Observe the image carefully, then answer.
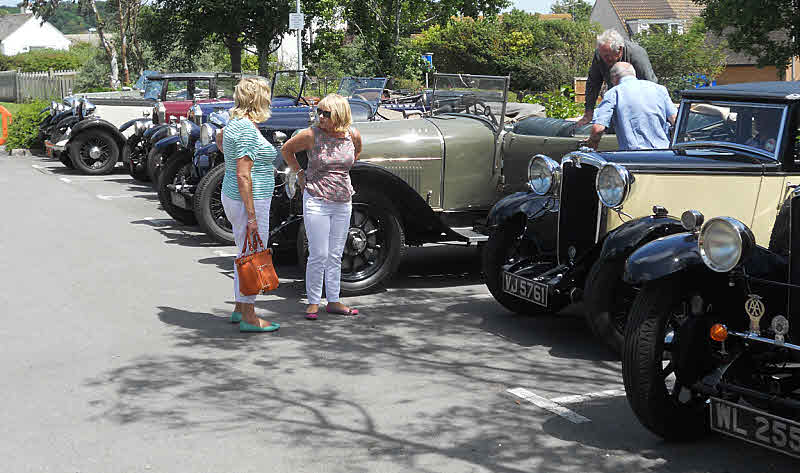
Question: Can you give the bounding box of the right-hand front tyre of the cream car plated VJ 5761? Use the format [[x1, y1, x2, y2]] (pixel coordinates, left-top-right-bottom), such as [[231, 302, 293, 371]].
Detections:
[[584, 259, 636, 355]]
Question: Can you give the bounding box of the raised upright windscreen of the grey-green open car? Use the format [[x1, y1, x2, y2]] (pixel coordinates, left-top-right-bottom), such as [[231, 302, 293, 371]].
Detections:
[[431, 74, 508, 125]]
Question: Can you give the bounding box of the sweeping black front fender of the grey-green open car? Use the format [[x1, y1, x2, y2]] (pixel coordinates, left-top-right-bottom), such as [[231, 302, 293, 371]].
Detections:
[[350, 162, 448, 243]]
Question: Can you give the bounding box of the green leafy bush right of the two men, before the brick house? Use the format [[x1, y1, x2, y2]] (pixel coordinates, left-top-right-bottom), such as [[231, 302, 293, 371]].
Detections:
[[635, 19, 725, 99]]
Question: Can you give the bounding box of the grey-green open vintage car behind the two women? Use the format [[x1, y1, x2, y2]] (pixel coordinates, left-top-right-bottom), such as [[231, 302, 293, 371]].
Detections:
[[184, 74, 617, 294]]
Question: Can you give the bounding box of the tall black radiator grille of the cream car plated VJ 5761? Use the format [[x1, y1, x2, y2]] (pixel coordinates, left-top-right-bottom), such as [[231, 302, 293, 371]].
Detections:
[[558, 162, 599, 263]]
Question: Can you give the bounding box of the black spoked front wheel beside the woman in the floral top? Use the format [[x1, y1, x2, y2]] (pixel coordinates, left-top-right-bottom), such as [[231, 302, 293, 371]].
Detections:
[[297, 191, 405, 296]]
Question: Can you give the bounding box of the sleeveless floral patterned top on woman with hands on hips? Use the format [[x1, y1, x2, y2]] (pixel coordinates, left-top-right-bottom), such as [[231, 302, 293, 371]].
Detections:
[[306, 126, 356, 202]]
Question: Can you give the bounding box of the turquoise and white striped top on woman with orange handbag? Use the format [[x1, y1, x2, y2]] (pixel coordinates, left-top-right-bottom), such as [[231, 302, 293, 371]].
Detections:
[[222, 118, 277, 200]]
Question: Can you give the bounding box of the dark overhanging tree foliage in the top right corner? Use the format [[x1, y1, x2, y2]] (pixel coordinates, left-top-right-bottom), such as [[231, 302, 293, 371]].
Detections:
[[694, 0, 800, 69]]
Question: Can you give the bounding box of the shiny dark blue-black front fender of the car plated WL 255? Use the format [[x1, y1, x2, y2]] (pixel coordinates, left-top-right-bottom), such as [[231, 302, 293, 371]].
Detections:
[[623, 231, 710, 284]]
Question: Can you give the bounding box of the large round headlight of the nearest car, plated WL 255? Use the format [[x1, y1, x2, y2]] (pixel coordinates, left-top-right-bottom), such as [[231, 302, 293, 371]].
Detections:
[[697, 217, 755, 273]]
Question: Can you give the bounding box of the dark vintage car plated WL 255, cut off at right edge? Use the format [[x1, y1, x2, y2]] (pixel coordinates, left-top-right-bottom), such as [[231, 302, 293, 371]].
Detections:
[[622, 206, 800, 458]]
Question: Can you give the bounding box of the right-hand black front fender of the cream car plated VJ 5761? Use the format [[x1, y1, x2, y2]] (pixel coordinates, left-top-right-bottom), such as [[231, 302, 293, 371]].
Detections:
[[598, 215, 686, 260]]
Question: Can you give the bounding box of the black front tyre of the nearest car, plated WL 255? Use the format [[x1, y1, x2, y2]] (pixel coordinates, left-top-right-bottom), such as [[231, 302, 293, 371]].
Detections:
[[622, 277, 708, 441]]
